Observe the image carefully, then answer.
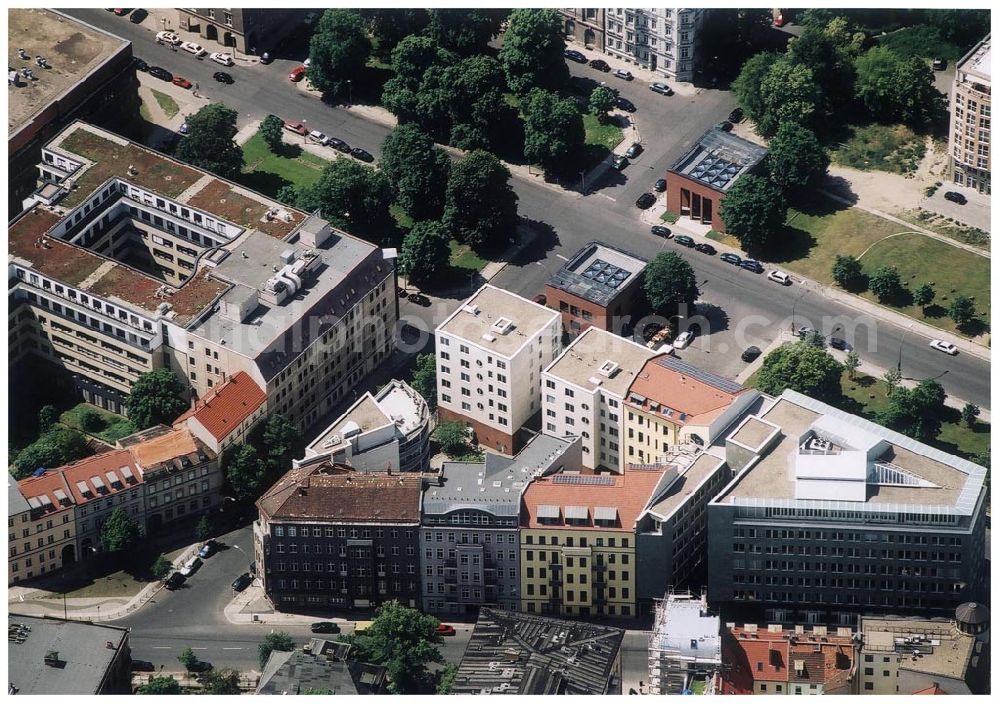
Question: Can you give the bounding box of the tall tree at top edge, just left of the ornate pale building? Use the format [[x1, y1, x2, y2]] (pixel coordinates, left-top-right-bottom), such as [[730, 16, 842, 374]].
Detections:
[[500, 8, 569, 95]]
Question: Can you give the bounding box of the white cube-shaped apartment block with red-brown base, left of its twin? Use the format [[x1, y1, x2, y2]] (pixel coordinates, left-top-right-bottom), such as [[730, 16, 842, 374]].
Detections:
[[435, 284, 562, 455]]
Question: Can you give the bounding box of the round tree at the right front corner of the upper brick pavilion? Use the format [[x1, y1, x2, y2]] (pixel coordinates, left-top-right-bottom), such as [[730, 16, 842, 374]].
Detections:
[[720, 174, 787, 253]]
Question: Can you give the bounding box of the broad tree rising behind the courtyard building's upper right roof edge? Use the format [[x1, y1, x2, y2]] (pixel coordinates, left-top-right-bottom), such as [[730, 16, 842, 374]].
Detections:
[[299, 159, 392, 244]]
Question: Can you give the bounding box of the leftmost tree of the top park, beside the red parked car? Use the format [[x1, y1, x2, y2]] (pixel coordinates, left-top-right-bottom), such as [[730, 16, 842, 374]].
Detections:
[[306, 9, 372, 95]]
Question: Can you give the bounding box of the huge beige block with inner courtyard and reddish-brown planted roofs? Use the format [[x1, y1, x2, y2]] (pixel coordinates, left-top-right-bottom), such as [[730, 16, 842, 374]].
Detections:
[[8, 122, 397, 427]]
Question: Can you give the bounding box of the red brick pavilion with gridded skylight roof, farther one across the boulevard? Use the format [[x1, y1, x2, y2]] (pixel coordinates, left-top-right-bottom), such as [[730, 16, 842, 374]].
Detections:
[[666, 127, 767, 232]]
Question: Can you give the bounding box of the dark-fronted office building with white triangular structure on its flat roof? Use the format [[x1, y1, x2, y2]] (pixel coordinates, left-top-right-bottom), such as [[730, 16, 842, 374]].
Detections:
[[708, 390, 987, 625]]
